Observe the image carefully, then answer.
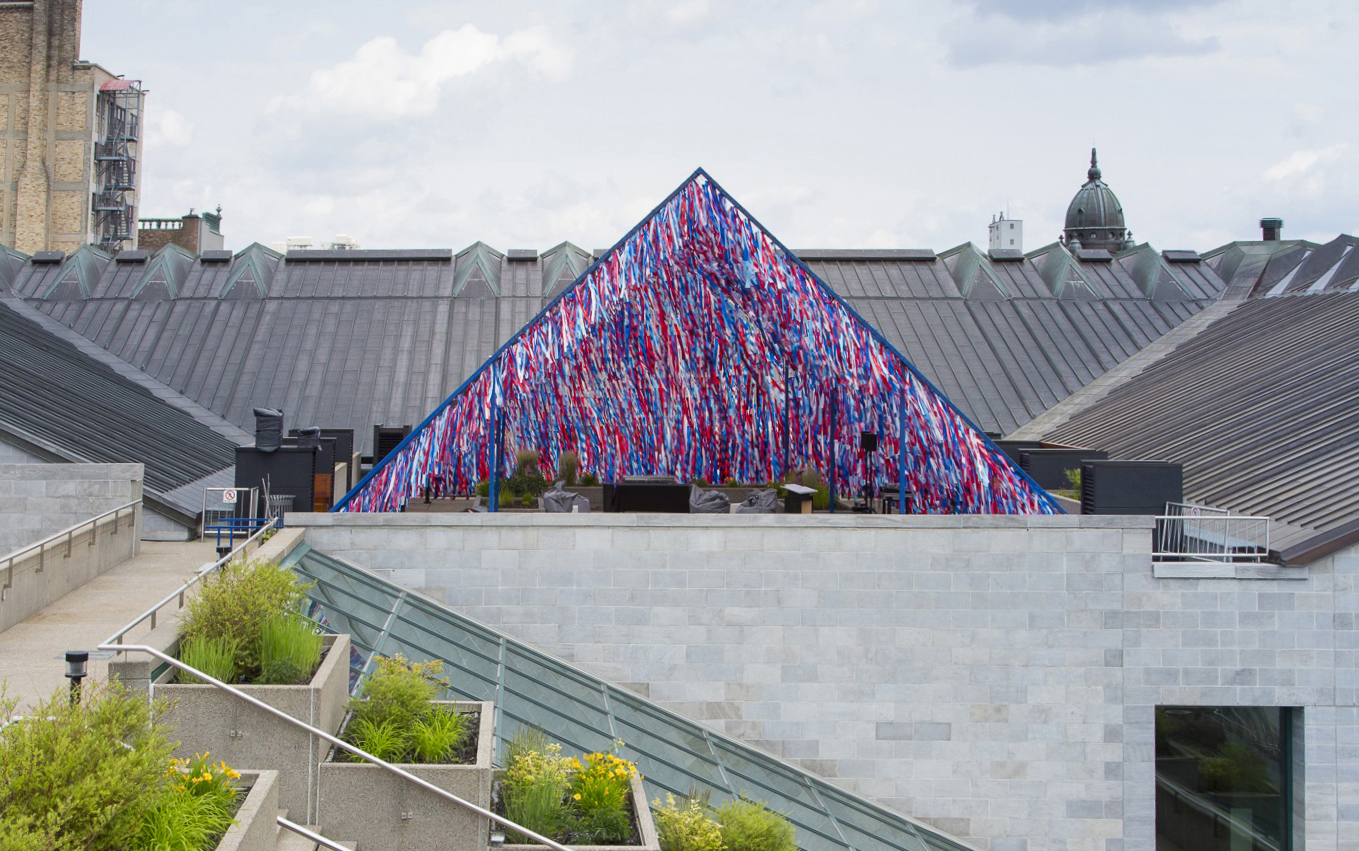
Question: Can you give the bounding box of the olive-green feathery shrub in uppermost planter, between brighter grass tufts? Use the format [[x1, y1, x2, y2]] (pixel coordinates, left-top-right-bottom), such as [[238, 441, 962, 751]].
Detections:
[[182, 560, 307, 680]]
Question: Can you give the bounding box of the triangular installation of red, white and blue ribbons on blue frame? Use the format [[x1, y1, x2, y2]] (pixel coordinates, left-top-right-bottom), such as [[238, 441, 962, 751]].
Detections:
[[334, 169, 1061, 514]]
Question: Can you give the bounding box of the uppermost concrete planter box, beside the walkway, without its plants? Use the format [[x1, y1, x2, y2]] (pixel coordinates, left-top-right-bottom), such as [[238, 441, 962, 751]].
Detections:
[[155, 635, 349, 824]]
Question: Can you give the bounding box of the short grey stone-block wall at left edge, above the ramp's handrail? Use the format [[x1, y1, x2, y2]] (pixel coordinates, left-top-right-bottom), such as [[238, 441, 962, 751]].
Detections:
[[0, 459, 144, 553]]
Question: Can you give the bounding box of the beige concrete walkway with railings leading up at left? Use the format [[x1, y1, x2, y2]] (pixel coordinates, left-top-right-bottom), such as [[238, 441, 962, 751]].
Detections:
[[0, 541, 217, 712]]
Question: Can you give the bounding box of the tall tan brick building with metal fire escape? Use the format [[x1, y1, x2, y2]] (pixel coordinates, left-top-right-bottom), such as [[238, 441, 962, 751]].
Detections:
[[0, 0, 145, 254]]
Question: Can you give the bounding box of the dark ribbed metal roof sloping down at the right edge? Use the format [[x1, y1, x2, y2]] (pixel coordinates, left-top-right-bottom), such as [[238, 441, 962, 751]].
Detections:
[[1046, 285, 1359, 549]]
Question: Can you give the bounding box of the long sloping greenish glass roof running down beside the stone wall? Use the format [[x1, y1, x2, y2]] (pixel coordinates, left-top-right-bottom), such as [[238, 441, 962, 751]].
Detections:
[[287, 545, 969, 851]]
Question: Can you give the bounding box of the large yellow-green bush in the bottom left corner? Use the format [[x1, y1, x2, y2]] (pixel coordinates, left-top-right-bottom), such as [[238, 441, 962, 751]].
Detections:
[[0, 685, 171, 851]]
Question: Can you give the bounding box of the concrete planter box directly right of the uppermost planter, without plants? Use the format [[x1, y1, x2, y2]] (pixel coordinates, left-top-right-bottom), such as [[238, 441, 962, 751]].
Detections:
[[317, 701, 495, 851]]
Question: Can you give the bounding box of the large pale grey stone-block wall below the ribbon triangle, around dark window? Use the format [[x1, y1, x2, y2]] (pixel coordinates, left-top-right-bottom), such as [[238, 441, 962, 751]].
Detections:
[[297, 514, 1359, 851]]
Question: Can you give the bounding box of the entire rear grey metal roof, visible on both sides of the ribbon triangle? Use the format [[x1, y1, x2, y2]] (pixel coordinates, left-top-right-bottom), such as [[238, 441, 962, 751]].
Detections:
[[5, 235, 1223, 453]]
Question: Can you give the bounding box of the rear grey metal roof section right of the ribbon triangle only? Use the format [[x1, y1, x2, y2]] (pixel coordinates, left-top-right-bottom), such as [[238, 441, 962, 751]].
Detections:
[[803, 243, 1223, 434]]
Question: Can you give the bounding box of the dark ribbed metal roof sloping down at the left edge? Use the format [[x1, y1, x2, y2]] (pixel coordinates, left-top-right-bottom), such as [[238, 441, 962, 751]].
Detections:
[[0, 297, 235, 505]]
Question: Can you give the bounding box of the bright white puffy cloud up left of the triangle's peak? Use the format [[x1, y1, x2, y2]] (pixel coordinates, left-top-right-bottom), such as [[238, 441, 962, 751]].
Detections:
[[306, 23, 572, 118]]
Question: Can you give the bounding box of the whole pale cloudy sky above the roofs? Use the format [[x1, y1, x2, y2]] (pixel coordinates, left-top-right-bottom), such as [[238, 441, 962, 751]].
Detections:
[[82, 0, 1359, 250]]
